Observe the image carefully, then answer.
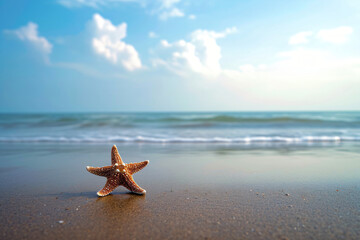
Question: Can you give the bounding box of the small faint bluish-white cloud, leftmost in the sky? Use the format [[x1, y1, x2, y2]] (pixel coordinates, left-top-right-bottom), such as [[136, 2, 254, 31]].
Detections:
[[5, 22, 53, 54]]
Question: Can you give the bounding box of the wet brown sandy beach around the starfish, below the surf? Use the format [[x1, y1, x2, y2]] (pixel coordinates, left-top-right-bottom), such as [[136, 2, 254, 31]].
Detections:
[[0, 143, 360, 239]]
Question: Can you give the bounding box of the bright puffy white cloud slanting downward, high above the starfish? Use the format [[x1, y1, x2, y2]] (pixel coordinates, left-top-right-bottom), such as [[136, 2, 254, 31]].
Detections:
[[92, 14, 141, 71]]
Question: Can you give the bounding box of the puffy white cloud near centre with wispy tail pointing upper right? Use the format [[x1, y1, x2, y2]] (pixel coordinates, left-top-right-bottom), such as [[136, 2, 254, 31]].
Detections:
[[155, 27, 237, 77]]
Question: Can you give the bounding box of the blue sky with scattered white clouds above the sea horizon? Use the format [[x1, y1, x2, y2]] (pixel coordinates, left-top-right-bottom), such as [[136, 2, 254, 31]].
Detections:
[[0, 0, 360, 112]]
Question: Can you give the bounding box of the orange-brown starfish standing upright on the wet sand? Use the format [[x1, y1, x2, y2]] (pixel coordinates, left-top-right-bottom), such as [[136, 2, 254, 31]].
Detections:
[[86, 145, 149, 197]]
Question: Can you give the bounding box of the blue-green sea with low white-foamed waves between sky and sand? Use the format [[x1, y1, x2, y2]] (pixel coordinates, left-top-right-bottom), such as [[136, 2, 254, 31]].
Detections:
[[0, 112, 360, 145]]
